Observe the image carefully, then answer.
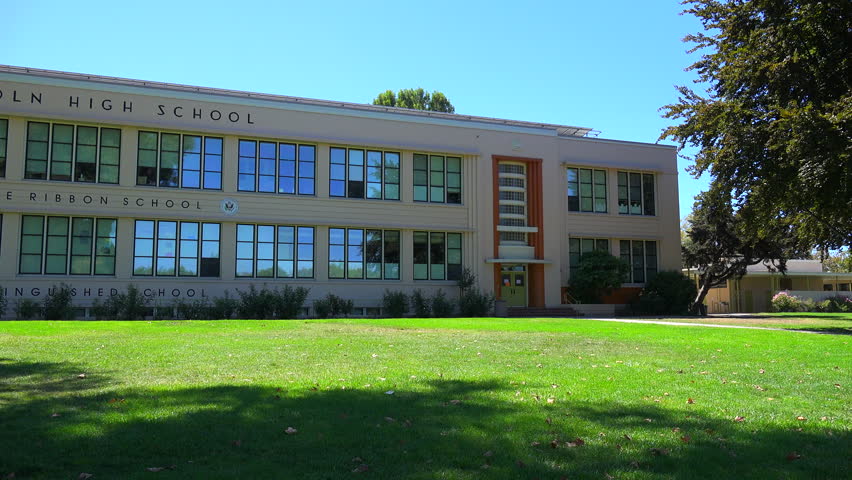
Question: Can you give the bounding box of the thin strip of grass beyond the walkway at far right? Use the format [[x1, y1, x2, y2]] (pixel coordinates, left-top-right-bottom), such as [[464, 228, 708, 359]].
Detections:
[[624, 312, 852, 335]]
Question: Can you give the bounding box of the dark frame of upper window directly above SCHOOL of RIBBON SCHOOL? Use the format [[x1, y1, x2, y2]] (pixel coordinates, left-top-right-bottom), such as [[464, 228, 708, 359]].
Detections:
[[135, 129, 225, 191]]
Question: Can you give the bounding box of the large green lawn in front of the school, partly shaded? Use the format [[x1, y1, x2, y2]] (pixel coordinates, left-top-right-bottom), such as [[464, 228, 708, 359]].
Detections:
[[0, 319, 852, 480]]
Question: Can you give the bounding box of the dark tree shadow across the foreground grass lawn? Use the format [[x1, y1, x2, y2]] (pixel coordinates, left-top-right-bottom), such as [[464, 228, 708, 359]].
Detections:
[[0, 360, 850, 480]]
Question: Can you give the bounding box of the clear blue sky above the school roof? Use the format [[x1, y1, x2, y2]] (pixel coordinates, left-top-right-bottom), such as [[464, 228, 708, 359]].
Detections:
[[0, 0, 707, 217]]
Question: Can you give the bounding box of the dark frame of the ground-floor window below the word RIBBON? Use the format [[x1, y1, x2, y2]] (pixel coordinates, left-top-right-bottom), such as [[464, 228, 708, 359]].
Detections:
[[18, 215, 118, 277]]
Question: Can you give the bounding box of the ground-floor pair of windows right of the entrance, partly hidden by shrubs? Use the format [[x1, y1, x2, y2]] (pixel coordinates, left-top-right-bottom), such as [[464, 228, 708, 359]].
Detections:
[[568, 237, 658, 283]]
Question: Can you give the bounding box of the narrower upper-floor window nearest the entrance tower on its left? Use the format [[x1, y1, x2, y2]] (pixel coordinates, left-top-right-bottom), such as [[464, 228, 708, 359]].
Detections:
[[414, 153, 461, 203]]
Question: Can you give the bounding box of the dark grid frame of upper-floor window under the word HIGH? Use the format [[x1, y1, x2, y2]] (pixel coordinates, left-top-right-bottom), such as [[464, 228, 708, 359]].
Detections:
[[24, 119, 123, 185]]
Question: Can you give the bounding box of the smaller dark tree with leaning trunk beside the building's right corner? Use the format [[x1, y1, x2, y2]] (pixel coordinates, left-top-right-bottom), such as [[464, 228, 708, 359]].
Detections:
[[682, 188, 808, 313]]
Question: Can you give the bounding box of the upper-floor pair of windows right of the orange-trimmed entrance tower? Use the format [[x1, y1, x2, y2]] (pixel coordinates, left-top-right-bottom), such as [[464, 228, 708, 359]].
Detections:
[[567, 167, 656, 216]]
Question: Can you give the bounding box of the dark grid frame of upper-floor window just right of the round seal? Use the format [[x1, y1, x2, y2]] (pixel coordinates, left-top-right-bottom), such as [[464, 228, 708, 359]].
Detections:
[[237, 138, 317, 196]]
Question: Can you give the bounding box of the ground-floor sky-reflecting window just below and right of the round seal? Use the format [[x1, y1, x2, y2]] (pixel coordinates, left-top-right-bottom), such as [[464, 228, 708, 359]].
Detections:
[[236, 224, 314, 278]]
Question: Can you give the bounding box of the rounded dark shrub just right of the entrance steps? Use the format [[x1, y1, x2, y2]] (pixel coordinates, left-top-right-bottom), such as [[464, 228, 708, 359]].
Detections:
[[571, 252, 630, 303]]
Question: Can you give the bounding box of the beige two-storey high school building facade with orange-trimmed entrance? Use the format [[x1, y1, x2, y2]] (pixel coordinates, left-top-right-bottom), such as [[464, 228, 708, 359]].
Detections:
[[0, 66, 681, 316]]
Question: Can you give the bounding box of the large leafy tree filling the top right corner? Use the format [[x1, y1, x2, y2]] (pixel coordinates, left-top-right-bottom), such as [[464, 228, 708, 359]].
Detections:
[[661, 0, 852, 249]]
